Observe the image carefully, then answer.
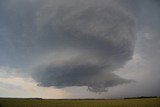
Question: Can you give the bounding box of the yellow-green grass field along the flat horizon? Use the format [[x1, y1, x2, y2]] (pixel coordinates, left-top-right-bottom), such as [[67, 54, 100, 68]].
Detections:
[[0, 98, 160, 107]]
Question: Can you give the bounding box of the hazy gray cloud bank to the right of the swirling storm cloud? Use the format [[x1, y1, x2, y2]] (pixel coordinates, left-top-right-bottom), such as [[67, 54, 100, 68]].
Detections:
[[116, 0, 160, 96]]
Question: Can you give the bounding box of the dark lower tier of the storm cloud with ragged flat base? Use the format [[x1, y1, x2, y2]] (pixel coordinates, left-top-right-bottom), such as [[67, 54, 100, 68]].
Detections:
[[33, 52, 131, 92]]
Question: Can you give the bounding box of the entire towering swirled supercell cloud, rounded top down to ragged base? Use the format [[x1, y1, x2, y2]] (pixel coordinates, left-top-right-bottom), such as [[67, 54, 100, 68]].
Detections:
[[32, 0, 135, 92]]
